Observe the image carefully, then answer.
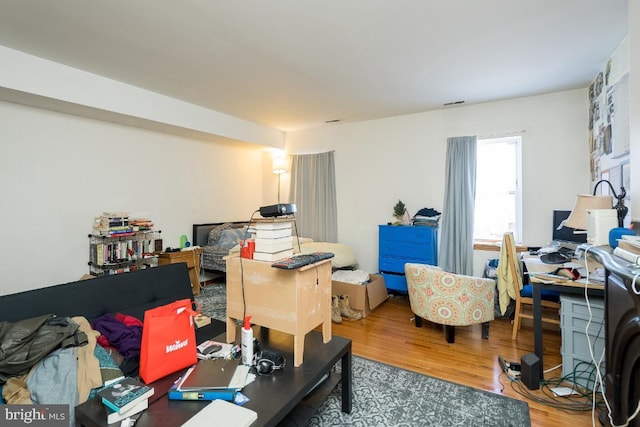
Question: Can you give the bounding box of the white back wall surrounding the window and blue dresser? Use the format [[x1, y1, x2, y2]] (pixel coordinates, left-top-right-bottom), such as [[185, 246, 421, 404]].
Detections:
[[286, 89, 590, 274]]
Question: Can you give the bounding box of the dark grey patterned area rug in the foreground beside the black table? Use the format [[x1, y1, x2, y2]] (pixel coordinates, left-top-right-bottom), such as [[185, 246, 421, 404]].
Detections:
[[307, 356, 531, 427]]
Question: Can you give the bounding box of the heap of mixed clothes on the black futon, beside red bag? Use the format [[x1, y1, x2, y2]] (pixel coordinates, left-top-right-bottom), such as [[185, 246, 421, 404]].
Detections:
[[0, 314, 142, 425]]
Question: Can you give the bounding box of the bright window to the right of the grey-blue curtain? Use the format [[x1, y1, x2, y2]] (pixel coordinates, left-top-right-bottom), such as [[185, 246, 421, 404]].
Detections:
[[473, 136, 522, 242]]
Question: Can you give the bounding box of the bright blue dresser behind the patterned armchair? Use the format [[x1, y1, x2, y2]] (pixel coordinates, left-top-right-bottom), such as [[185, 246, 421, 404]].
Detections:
[[378, 225, 438, 293]]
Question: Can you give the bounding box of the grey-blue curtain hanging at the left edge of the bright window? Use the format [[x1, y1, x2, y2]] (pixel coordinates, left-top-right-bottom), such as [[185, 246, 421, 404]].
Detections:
[[439, 136, 477, 276]]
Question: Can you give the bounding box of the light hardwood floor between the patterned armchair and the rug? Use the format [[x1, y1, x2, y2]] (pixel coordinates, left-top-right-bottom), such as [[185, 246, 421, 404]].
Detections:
[[332, 295, 600, 427]]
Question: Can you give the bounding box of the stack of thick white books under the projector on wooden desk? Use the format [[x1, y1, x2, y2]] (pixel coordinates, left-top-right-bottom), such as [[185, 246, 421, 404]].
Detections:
[[253, 218, 294, 262]]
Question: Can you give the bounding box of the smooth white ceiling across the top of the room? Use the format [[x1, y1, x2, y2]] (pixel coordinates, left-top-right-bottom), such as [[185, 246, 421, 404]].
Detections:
[[0, 0, 628, 131]]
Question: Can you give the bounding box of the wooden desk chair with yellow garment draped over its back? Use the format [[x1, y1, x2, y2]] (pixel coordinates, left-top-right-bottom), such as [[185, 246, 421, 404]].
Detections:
[[498, 233, 560, 340]]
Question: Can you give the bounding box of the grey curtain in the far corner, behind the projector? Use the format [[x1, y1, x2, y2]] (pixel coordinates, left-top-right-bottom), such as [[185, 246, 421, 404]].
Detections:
[[289, 151, 338, 242]]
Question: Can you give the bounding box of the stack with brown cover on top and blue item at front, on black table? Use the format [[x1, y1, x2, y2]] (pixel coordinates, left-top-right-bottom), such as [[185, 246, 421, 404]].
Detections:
[[168, 359, 249, 401]]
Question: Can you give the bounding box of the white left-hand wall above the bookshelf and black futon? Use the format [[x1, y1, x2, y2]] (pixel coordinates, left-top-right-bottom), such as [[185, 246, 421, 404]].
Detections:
[[0, 101, 264, 294]]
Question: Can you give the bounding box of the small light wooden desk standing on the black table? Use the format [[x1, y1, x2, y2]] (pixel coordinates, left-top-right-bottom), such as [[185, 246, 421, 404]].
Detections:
[[226, 255, 331, 367]]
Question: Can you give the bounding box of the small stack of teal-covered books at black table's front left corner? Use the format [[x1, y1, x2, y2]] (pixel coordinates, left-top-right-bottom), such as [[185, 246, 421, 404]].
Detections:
[[96, 377, 155, 424]]
